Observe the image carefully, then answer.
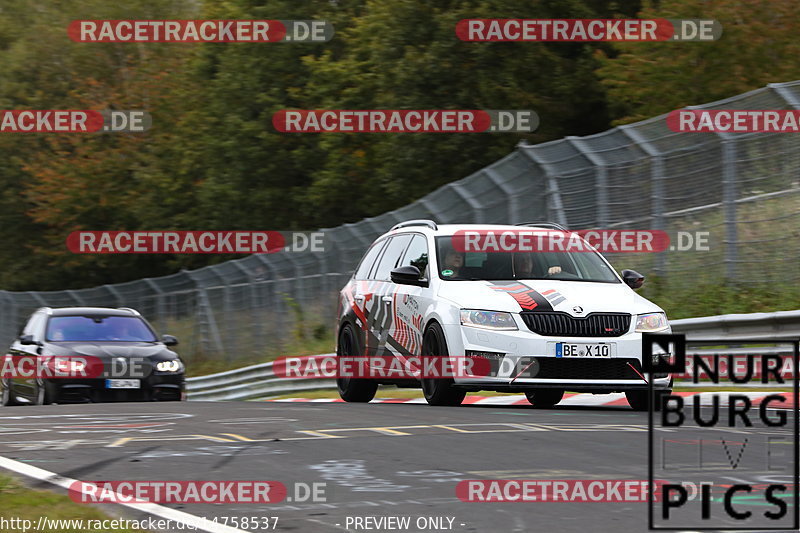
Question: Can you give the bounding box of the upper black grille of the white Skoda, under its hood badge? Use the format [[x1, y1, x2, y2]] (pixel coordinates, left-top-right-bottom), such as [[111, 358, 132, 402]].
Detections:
[[521, 311, 631, 337]]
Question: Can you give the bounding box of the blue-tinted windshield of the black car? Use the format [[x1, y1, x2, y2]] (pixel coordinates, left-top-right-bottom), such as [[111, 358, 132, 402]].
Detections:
[[45, 316, 156, 342]]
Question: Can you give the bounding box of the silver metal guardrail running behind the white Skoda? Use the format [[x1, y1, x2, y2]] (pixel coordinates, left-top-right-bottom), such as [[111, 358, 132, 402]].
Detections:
[[186, 310, 800, 400]]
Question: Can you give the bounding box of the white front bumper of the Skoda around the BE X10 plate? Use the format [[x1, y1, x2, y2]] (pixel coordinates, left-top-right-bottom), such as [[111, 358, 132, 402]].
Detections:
[[444, 324, 671, 392]]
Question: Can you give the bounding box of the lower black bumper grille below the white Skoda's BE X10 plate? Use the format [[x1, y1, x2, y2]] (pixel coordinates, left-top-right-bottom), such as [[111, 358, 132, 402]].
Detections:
[[520, 357, 641, 380]]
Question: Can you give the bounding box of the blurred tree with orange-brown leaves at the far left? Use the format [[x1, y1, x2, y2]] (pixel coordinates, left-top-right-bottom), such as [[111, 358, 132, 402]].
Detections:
[[0, 0, 198, 289]]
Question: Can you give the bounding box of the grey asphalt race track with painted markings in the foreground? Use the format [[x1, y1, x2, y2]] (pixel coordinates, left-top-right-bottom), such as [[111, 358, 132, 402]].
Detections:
[[0, 402, 790, 532]]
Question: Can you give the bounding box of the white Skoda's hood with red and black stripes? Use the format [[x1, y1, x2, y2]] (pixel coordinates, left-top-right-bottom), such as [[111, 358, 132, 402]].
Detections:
[[438, 280, 662, 316]]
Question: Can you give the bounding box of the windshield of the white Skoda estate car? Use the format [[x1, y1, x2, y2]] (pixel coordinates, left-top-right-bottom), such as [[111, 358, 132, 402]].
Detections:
[[436, 236, 620, 283]]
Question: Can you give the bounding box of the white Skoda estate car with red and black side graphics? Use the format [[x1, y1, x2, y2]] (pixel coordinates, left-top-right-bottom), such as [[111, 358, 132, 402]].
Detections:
[[337, 220, 671, 410]]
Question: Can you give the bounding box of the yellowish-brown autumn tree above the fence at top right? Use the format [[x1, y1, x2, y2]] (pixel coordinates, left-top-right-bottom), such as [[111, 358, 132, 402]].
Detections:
[[598, 0, 800, 124]]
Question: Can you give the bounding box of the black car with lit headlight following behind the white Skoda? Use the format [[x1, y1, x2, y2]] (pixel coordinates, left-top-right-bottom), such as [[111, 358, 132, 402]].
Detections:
[[0, 307, 185, 405]]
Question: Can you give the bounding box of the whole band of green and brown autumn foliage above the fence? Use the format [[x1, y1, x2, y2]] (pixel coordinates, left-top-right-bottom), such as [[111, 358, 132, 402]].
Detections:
[[0, 0, 800, 290]]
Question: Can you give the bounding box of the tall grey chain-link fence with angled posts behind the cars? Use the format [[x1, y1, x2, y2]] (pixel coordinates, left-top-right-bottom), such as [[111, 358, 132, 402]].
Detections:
[[0, 81, 800, 361]]
